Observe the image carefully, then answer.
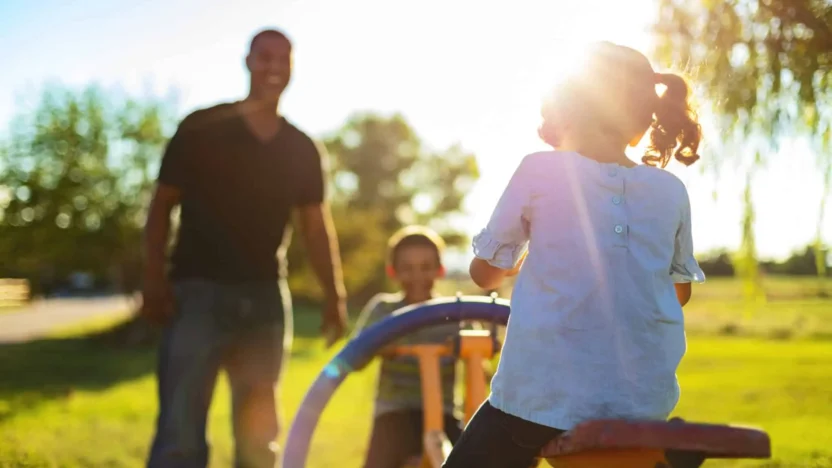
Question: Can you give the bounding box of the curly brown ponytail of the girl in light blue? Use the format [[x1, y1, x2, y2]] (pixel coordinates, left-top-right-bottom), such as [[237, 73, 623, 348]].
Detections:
[[642, 73, 702, 167]]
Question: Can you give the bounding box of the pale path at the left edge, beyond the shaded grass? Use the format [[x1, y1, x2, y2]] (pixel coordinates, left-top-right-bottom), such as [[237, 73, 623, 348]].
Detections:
[[0, 296, 130, 344]]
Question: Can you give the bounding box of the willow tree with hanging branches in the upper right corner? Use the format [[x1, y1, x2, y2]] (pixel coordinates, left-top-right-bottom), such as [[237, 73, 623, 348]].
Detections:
[[655, 0, 832, 292]]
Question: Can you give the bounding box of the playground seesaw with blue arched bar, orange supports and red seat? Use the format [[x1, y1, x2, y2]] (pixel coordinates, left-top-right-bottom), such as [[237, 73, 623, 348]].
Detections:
[[283, 296, 771, 468]]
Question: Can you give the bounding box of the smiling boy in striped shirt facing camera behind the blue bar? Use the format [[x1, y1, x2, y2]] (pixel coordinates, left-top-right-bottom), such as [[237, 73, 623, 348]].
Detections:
[[356, 226, 462, 468]]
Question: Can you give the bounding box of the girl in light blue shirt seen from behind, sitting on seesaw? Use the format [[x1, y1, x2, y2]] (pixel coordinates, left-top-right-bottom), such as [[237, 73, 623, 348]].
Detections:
[[443, 42, 704, 468]]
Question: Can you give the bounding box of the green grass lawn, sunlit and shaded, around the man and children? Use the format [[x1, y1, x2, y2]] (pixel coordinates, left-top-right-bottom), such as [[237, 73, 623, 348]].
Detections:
[[0, 279, 832, 468]]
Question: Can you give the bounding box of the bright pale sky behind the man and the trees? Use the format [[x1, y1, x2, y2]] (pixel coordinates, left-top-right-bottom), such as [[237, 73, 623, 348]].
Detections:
[[0, 0, 832, 266]]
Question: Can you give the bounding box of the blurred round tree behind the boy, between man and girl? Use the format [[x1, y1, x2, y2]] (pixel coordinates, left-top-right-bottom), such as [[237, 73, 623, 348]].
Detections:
[[289, 113, 479, 300]]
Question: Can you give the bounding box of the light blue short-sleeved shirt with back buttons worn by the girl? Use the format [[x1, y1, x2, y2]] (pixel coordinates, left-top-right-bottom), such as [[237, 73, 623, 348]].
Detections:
[[473, 152, 705, 430]]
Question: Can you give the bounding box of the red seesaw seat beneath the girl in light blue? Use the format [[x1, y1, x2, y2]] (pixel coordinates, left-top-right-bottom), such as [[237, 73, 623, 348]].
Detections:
[[541, 419, 771, 468]]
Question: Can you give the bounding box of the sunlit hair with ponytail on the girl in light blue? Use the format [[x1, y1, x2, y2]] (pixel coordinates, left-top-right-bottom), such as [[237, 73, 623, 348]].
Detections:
[[538, 42, 702, 167]]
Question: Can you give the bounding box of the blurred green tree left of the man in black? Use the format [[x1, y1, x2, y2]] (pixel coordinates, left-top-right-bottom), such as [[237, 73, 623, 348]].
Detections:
[[0, 87, 173, 291]]
